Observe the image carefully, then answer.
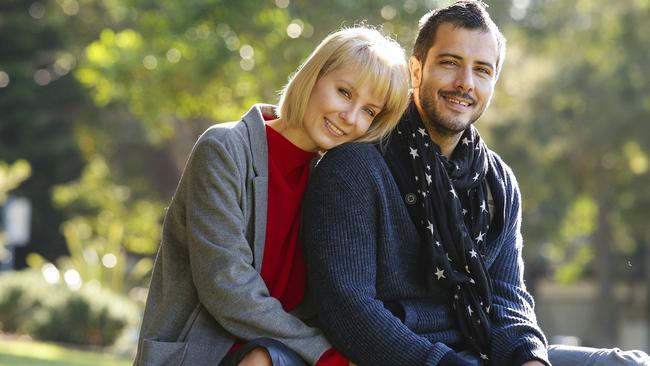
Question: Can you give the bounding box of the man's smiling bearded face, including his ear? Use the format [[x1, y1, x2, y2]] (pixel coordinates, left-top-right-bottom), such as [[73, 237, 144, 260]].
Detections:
[[410, 23, 499, 136]]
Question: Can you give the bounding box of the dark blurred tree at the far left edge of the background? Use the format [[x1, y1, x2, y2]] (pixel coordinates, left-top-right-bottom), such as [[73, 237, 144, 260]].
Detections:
[[0, 0, 85, 267]]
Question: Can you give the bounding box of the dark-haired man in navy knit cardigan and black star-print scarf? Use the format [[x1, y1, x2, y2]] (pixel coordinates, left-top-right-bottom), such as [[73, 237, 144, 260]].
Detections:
[[303, 0, 650, 366]]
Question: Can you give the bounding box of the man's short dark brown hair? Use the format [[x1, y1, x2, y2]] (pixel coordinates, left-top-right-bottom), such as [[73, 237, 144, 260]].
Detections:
[[413, 0, 506, 75]]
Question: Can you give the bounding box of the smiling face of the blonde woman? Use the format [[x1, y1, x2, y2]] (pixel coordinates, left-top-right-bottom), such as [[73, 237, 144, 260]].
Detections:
[[301, 68, 385, 151]]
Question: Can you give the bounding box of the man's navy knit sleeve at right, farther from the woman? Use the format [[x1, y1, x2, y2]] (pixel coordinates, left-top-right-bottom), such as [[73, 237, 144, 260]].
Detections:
[[490, 169, 550, 366]]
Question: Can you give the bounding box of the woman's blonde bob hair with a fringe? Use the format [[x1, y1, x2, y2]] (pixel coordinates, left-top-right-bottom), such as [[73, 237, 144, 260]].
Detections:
[[277, 26, 409, 142]]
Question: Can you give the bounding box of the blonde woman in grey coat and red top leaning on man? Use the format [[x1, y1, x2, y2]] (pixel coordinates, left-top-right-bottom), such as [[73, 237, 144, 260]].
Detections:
[[135, 27, 408, 365]]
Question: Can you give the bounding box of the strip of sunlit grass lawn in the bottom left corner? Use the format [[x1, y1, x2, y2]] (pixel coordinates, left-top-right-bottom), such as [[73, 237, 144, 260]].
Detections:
[[0, 339, 133, 366]]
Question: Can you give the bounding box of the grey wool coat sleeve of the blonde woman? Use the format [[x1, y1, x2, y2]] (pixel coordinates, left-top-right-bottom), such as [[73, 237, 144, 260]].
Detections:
[[183, 133, 330, 365]]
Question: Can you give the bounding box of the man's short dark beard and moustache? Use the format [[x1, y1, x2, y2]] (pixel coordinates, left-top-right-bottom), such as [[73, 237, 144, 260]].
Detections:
[[419, 85, 484, 136]]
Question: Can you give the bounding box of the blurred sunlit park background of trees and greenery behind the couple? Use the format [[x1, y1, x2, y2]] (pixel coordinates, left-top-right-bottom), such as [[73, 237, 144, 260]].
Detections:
[[0, 0, 650, 365]]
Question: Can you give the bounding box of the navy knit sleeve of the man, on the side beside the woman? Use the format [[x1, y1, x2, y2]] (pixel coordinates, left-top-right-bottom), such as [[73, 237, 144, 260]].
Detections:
[[303, 144, 450, 366]]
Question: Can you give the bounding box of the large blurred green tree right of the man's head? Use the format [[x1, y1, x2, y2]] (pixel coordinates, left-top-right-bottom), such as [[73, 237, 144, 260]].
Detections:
[[486, 1, 650, 345]]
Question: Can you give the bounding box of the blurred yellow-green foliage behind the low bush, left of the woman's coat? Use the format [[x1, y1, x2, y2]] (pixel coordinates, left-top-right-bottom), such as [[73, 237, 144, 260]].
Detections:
[[53, 157, 163, 292]]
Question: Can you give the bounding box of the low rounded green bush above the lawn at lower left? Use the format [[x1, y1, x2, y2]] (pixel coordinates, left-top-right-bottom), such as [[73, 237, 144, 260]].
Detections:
[[0, 271, 139, 346]]
